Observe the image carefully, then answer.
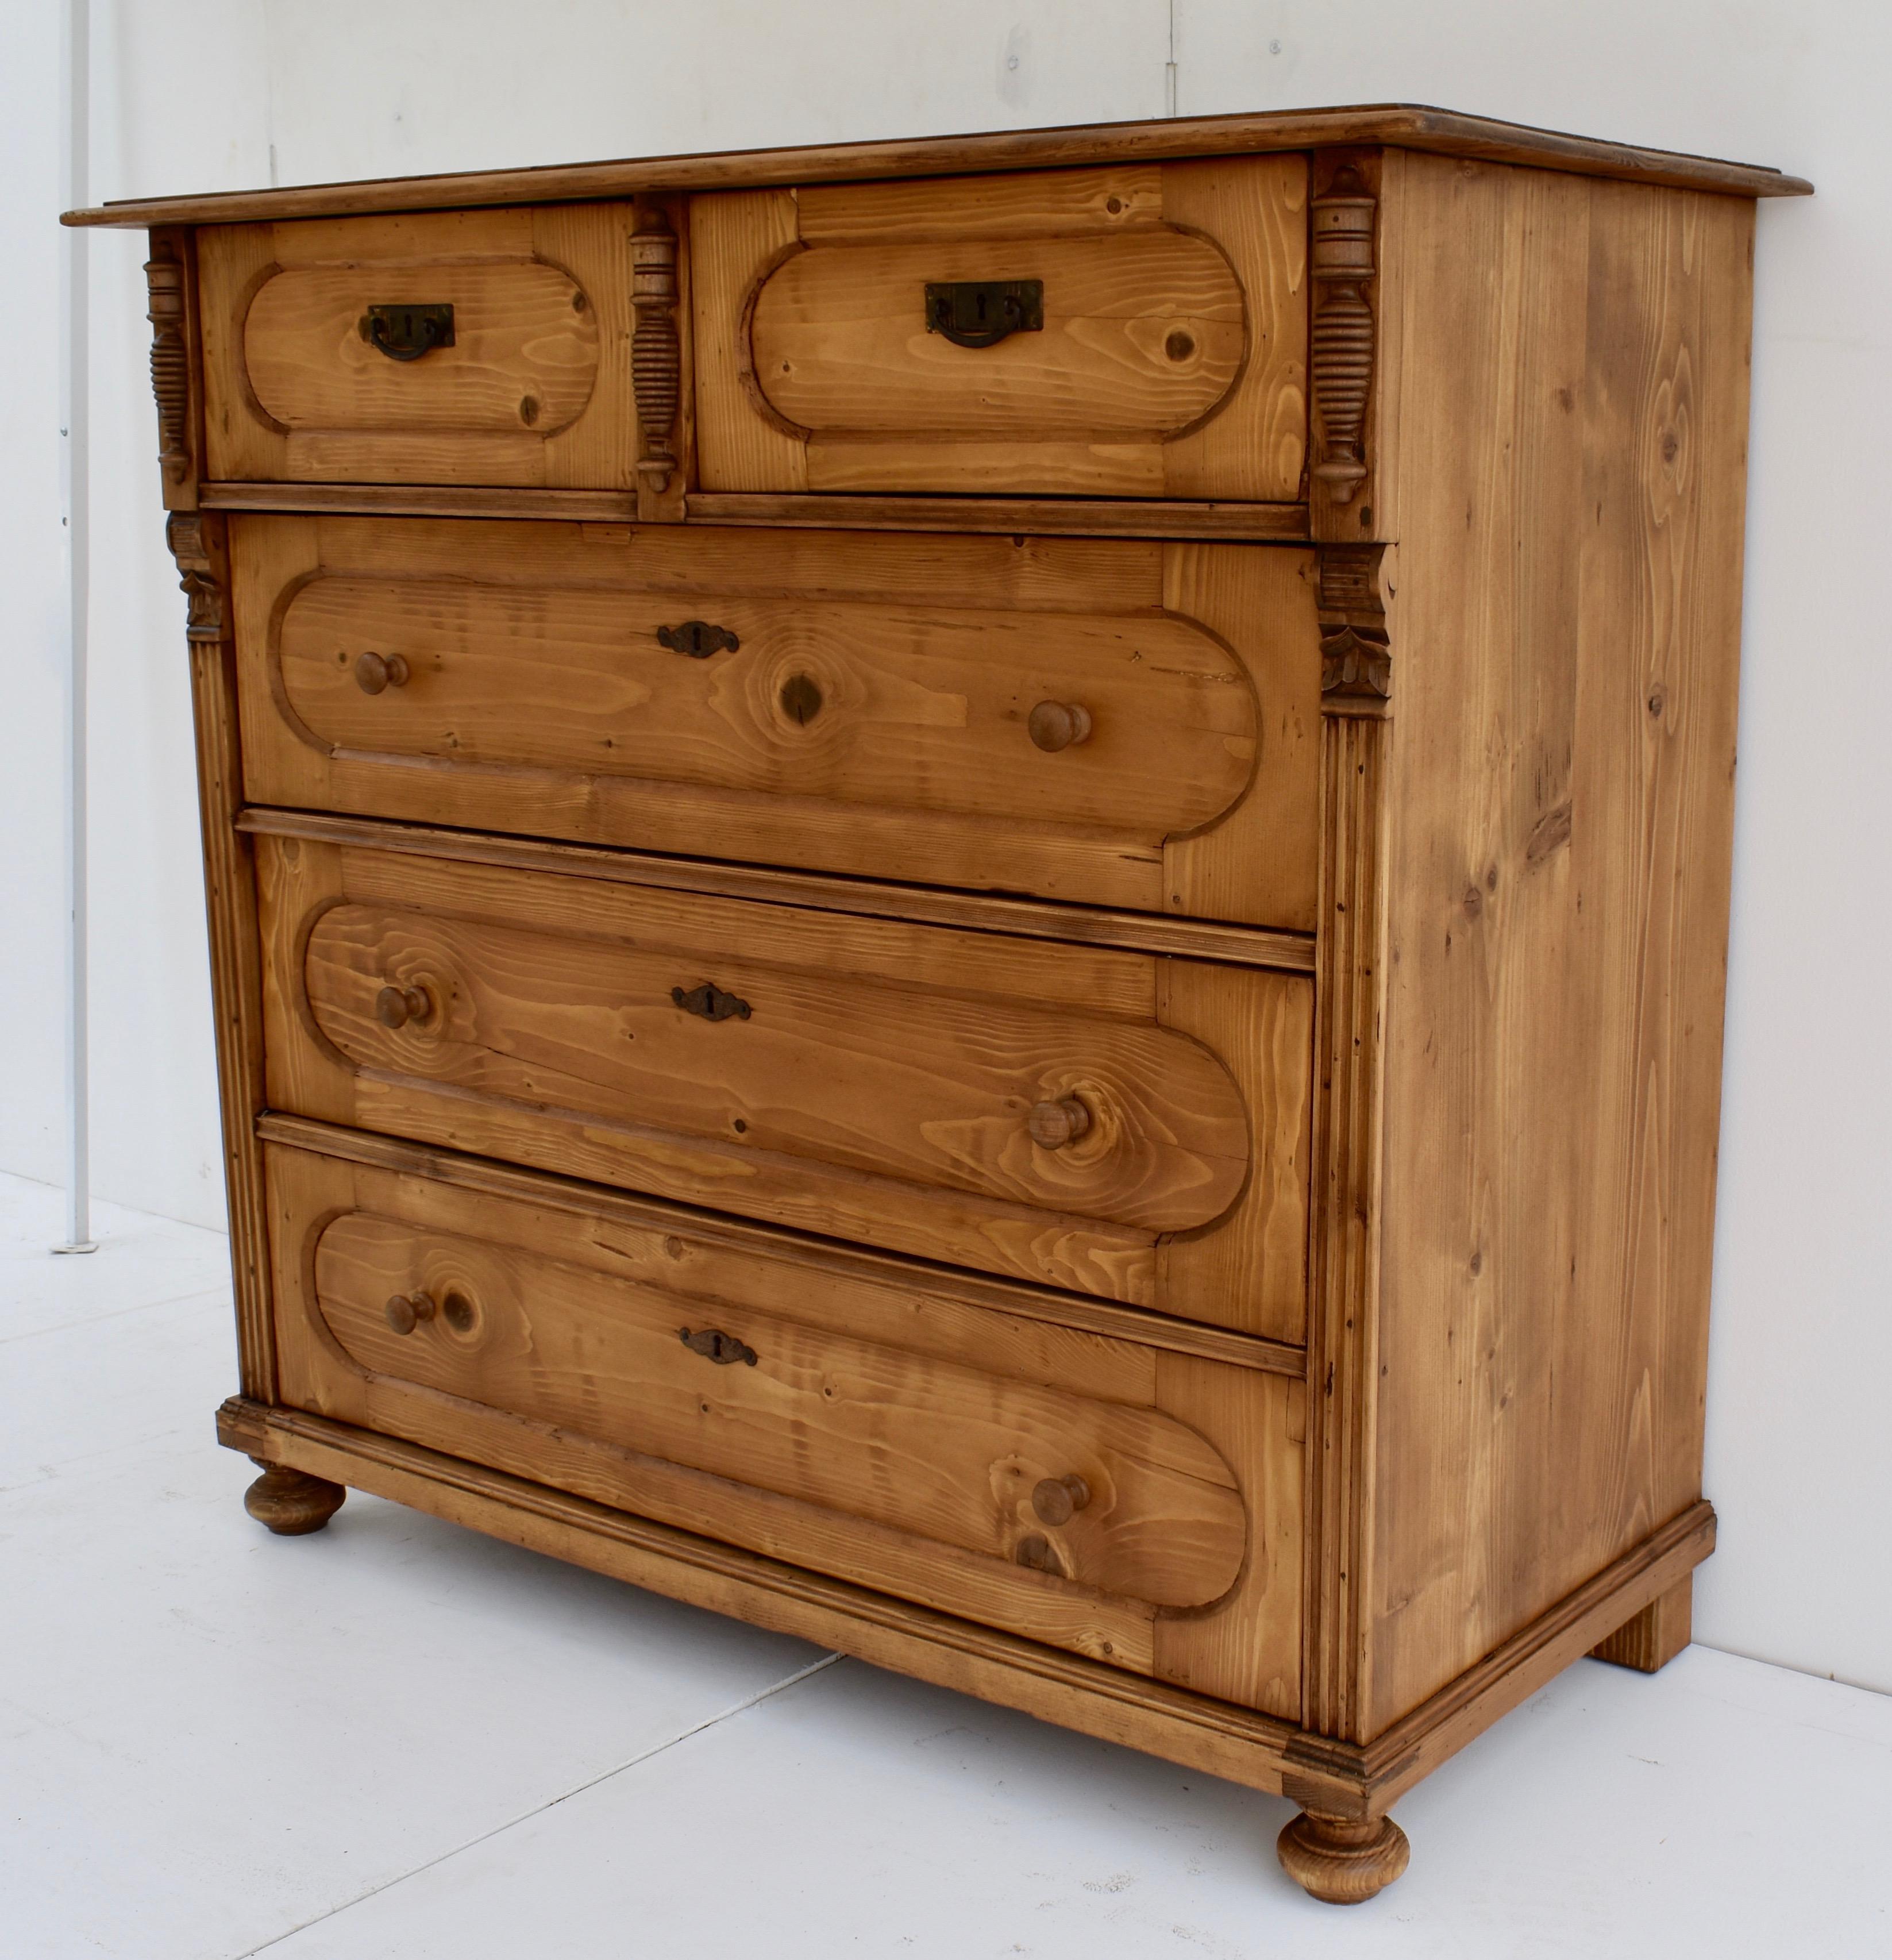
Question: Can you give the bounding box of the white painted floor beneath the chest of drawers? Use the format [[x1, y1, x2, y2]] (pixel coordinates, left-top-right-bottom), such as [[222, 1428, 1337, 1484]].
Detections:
[[0, 1178, 1892, 1960]]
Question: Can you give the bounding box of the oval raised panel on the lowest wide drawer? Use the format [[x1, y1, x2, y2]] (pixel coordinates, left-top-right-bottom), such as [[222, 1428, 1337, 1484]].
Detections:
[[314, 1211, 1247, 1607]]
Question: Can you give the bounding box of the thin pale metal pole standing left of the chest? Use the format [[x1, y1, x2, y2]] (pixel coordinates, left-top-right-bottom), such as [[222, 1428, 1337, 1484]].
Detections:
[[53, 0, 98, 1253]]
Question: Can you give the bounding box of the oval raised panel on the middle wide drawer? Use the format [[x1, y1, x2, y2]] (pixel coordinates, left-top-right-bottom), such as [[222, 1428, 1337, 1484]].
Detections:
[[302, 906, 1249, 1233]]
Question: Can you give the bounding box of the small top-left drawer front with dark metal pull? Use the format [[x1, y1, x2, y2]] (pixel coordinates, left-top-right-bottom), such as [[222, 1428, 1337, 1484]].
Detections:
[[198, 204, 637, 488]]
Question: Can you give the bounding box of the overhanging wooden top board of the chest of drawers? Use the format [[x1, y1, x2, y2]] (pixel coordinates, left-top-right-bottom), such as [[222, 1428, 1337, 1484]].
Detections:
[[61, 104, 1814, 225]]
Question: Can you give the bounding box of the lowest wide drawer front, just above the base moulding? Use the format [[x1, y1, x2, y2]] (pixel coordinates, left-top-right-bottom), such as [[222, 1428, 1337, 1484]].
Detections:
[[267, 1146, 1302, 1715]]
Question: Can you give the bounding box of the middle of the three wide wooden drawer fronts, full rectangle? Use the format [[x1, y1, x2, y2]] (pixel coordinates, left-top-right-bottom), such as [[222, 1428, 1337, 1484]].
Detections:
[[259, 839, 1312, 1339]]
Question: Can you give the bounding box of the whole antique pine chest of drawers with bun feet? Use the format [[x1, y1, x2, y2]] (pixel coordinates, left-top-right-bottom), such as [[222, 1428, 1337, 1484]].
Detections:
[[78, 110, 1806, 1901]]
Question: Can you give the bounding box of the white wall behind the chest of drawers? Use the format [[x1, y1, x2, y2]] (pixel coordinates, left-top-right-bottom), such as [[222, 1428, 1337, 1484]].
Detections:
[[0, 0, 1892, 1689]]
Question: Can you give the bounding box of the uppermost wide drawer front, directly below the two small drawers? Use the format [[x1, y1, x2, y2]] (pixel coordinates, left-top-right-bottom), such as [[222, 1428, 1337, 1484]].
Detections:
[[233, 518, 1320, 931]]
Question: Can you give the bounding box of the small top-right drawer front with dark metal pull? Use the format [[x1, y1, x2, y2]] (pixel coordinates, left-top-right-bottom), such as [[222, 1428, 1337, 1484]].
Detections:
[[690, 157, 1308, 502]]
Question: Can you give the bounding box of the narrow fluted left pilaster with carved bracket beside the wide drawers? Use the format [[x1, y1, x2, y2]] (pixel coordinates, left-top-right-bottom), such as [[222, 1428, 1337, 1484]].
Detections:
[[165, 511, 276, 1401]]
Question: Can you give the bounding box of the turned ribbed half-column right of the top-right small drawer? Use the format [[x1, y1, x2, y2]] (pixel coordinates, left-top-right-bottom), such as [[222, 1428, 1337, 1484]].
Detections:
[[1308, 163, 1378, 506]]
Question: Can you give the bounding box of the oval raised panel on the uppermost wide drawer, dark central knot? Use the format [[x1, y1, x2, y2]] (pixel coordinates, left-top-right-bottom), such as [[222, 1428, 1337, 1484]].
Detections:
[[279, 576, 1255, 845]]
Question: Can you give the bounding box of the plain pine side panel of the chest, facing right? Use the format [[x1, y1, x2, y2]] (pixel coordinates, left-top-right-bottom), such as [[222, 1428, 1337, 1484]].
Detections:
[[1359, 157, 1753, 1735]]
